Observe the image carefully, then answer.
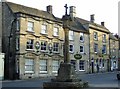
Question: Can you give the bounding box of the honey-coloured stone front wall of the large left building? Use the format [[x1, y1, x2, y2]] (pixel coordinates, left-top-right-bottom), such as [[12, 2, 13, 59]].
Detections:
[[16, 13, 64, 78]]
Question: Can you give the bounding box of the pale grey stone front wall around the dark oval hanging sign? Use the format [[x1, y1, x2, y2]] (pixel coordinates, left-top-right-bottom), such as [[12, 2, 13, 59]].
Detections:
[[70, 32, 89, 73]]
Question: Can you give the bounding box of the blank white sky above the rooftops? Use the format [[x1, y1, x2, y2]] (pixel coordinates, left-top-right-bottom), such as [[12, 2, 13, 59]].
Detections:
[[1, 0, 120, 35]]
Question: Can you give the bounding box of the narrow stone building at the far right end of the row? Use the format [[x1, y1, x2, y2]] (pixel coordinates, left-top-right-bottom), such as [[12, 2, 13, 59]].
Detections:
[[109, 33, 119, 71]]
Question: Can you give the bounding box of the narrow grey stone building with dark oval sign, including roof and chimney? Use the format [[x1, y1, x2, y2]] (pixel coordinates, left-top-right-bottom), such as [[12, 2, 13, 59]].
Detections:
[[69, 6, 89, 73]]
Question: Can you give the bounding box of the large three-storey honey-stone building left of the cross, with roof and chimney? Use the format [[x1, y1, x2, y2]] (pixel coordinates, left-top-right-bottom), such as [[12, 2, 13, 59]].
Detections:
[[3, 2, 64, 79]]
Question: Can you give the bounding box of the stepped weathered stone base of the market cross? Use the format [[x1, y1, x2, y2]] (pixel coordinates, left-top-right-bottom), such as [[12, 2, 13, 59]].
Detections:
[[43, 63, 88, 89]]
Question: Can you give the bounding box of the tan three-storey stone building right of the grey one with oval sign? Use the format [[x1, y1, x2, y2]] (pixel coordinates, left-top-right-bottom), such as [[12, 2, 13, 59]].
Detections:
[[81, 14, 110, 73]]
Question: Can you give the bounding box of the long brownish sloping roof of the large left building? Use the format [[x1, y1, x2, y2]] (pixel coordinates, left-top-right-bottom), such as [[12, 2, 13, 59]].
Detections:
[[6, 2, 61, 22]]
